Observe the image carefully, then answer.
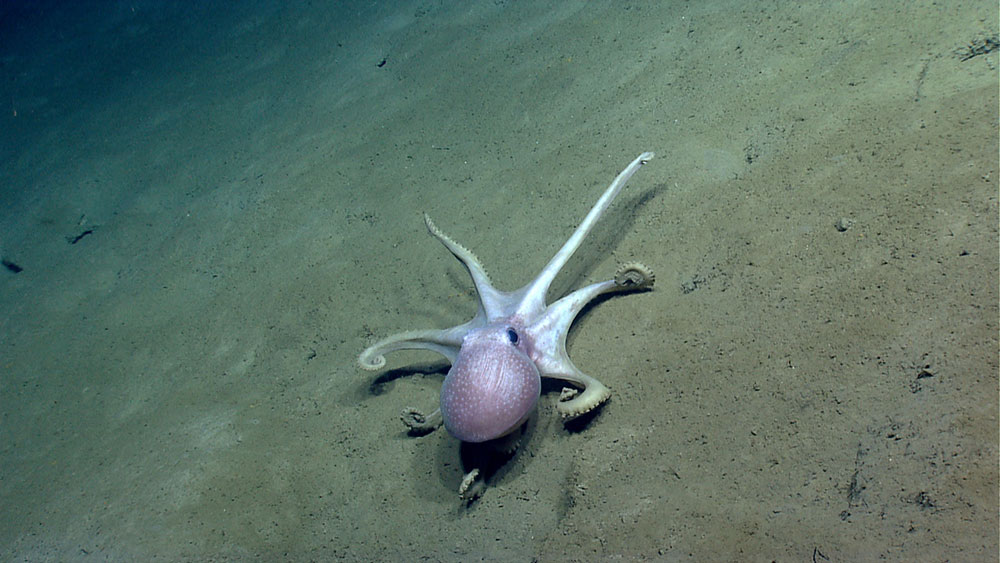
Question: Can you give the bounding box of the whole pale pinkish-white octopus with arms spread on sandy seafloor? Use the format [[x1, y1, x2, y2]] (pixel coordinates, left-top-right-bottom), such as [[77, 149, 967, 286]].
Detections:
[[358, 152, 654, 499]]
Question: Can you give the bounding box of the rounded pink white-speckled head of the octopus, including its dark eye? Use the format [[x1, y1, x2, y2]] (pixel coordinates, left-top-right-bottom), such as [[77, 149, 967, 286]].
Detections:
[[441, 322, 541, 442]]
